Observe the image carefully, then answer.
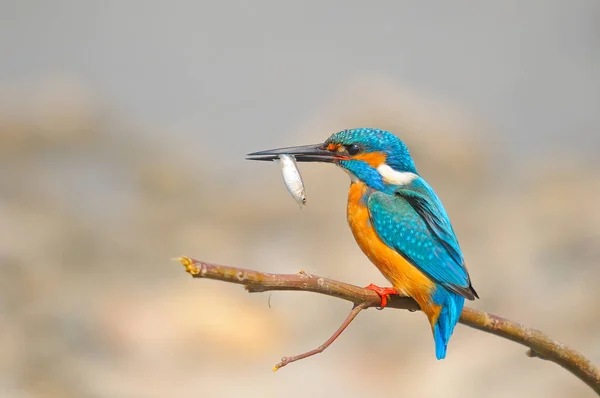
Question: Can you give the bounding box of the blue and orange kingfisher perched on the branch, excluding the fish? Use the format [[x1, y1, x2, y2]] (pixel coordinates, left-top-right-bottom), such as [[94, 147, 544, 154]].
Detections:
[[248, 128, 479, 359]]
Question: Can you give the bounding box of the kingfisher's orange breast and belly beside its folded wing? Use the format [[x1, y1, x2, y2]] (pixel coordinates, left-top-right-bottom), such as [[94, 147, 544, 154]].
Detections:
[[347, 182, 435, 312]]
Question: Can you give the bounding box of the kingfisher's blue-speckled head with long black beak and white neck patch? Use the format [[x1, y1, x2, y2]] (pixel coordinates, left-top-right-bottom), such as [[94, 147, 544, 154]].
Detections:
[[248, 128, 418, 190]]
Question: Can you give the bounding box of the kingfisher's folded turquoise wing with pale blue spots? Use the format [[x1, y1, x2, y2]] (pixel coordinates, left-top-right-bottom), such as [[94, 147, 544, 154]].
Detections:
[[368, 178, 477, 300]]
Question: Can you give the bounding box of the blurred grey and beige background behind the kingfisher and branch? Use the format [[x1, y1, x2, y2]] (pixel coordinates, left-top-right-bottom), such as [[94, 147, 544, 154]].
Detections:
[[0, 0, 600, 398]]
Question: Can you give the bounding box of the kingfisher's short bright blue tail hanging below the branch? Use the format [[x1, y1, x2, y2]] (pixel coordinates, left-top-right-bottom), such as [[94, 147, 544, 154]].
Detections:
[[430, 286, 465, 359]]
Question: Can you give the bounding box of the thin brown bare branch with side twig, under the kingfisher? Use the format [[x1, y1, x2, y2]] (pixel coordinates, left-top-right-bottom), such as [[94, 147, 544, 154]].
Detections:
[[177, 257, 600, 395]]
